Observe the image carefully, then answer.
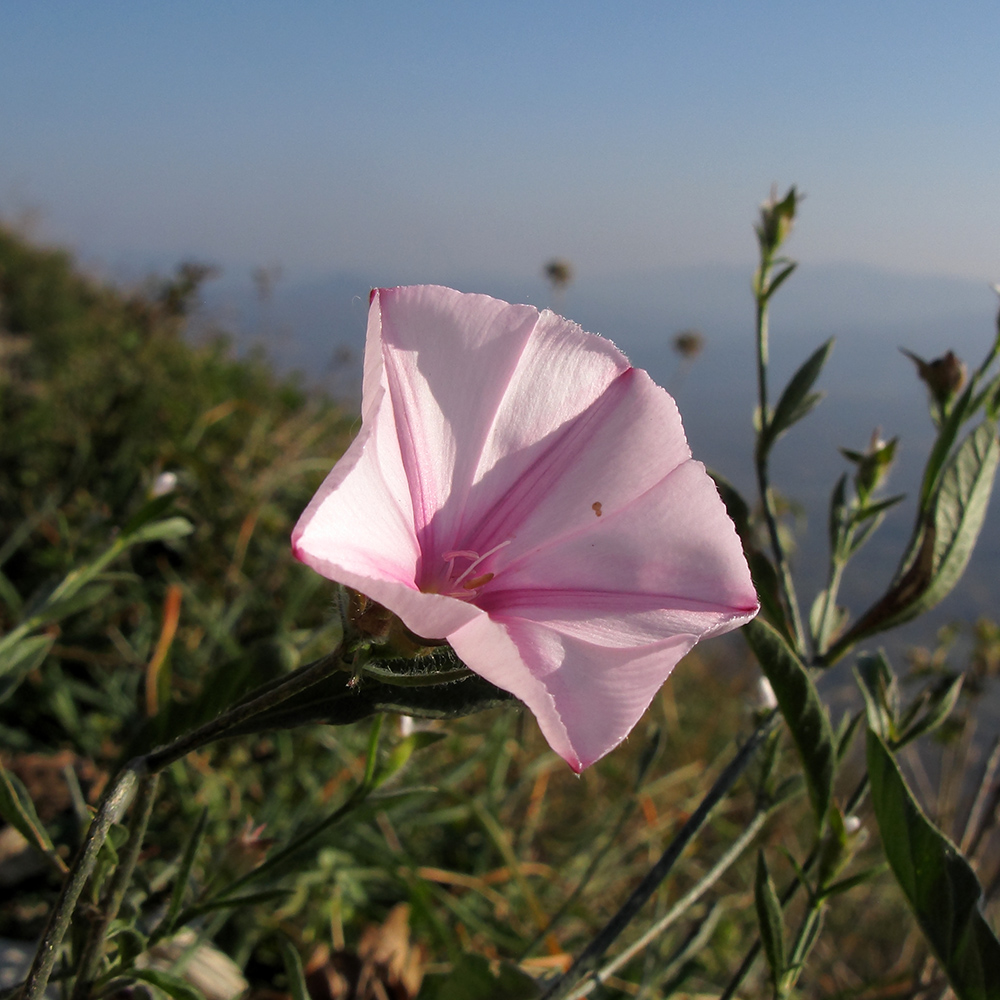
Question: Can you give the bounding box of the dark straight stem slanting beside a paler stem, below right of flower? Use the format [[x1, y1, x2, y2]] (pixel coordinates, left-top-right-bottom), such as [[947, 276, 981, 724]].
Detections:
[[541, 710, 778, 1000]]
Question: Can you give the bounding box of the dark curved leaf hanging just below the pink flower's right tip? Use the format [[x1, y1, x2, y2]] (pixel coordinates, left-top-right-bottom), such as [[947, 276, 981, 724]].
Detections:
[[743, 618, 837, 826]]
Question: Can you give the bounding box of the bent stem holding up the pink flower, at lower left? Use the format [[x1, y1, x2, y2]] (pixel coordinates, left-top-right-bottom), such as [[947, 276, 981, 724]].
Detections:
[[20, 646, 351, 1000]]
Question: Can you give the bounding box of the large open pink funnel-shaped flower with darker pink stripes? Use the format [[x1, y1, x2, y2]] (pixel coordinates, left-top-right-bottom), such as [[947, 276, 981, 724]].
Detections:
[[292, 285, 758, 771]]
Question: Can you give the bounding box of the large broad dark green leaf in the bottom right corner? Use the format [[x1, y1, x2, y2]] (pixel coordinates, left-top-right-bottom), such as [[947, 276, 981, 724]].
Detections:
[[868, 730, 1000, 1000]]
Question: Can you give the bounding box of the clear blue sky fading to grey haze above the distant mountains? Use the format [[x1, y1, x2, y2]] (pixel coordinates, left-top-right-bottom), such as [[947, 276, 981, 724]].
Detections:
[[0, 0, 1000, 281]]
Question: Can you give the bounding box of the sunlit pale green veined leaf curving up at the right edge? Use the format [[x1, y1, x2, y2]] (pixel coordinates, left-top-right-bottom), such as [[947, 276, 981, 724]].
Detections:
[[829, 422, 1000, 660]]
